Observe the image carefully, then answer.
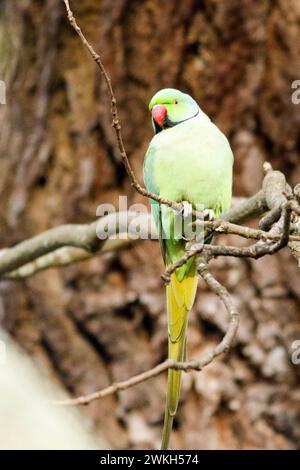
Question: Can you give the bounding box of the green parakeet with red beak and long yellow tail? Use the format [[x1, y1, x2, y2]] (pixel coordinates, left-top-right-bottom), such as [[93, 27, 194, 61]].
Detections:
[[144, 88, 233, 449]]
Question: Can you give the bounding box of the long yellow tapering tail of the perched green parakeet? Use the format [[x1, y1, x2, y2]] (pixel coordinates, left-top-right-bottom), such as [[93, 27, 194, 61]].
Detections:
[[161, 266, 198, 449]]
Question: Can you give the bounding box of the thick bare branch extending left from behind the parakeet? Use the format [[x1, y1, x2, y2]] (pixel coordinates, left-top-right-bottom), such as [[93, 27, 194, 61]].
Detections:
[[0, 212, 155, 278]]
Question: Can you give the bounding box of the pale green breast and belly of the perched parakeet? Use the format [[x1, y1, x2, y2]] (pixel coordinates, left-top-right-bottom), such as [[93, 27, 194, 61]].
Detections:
[[144, 115, 233, 264]]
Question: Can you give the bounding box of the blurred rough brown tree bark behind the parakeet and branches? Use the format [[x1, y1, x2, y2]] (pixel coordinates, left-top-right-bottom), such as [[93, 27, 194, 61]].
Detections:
[[0, 0, 300, 449]]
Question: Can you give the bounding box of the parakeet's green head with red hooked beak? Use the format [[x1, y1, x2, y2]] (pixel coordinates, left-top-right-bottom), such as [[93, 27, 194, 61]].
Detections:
[[149, 88, 200, 134]]
